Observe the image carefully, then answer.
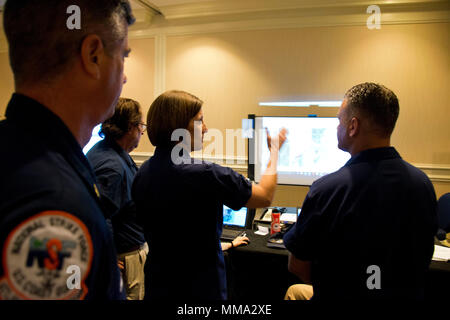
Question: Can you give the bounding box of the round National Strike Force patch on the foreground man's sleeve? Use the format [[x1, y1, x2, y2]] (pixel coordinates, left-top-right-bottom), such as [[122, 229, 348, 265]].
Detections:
[[0, 211, 94, 300]]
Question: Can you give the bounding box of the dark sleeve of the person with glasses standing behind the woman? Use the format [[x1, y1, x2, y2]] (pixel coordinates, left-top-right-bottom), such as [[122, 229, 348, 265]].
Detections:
[[97, 169, 122, 219]]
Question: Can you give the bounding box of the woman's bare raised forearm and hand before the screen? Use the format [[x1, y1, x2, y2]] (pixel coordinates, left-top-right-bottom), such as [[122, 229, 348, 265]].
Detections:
[[246, 128, 287, 208]]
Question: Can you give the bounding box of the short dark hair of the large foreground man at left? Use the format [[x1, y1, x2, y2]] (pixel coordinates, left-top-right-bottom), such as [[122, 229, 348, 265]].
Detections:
[[3, 0, 135, 84]]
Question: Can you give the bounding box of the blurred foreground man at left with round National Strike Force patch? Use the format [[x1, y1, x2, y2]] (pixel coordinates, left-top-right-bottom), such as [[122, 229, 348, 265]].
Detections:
[[0, 0, 134, 300]]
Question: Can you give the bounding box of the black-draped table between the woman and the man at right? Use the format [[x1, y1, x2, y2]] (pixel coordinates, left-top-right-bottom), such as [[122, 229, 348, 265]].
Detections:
[[225, 230, 450, 302]]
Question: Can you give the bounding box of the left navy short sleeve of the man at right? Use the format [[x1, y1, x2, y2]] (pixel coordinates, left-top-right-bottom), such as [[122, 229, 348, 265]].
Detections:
[[283, 191, 323, 261]]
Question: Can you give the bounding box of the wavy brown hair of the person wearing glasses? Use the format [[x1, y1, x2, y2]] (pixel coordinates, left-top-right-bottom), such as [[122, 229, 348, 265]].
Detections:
[[100, 98, 142, 140]]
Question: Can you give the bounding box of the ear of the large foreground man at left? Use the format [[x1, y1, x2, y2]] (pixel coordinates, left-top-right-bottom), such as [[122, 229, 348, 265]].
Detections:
[[81, 34, 105, 80]]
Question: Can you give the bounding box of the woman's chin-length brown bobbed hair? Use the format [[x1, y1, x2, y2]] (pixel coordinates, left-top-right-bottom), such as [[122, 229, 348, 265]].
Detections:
[[147, 90, 203, 147]]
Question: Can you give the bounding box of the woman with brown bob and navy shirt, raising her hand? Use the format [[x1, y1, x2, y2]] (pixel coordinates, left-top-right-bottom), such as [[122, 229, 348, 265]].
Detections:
[[132, 91, 286, 301]]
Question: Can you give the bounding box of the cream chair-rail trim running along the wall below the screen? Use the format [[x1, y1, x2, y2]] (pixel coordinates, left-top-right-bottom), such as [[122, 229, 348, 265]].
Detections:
[[130, 152, 450, 183]]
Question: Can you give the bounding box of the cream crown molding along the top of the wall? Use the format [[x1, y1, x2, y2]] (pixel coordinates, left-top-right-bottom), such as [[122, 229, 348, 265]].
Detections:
[[129, 0, 450, 38]]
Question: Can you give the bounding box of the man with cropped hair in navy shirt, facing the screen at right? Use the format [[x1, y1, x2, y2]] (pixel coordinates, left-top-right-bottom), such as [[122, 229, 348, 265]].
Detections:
[[284, 83, 437, 299]]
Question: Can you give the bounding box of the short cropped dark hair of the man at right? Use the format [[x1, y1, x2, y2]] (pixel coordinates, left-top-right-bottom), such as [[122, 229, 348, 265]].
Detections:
[[344, 82, 399, 137]]
